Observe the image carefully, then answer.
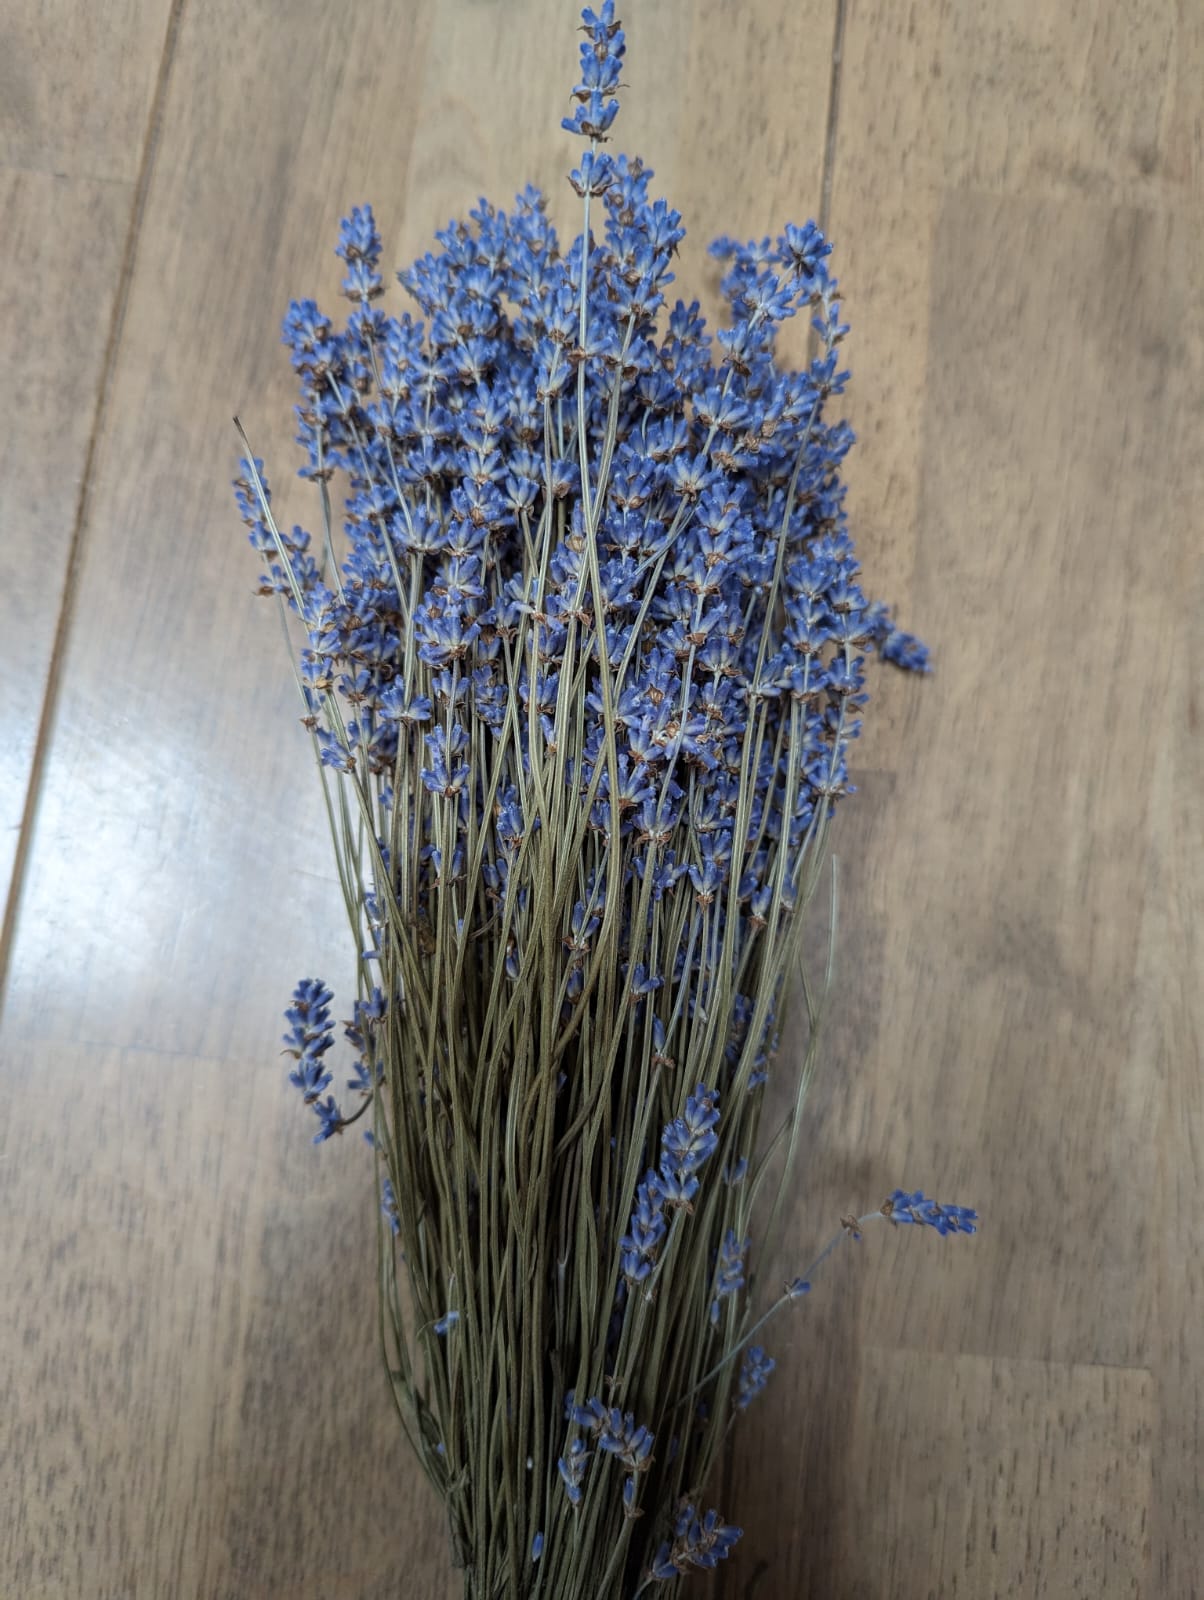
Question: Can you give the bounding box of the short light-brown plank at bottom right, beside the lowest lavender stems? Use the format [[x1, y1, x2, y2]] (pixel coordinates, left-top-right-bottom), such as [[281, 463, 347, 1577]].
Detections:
[[725, 1337, 1159, 1600]]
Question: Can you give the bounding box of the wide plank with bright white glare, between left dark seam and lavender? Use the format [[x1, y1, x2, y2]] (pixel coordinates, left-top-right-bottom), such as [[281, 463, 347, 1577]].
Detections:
[[0, 0, 448, 1056]]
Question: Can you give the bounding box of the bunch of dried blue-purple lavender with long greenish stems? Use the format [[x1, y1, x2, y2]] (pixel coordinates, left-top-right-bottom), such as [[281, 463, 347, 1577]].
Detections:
[[237, 0, 973, 1600]]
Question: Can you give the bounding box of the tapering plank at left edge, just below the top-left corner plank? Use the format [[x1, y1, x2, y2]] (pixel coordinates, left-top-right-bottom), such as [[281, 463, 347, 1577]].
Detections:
[[0, 166, 133, 907]]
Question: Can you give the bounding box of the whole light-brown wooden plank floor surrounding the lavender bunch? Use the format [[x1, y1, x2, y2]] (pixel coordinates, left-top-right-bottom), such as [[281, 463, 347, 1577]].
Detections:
[[0, 0, 1204, 1600]]
